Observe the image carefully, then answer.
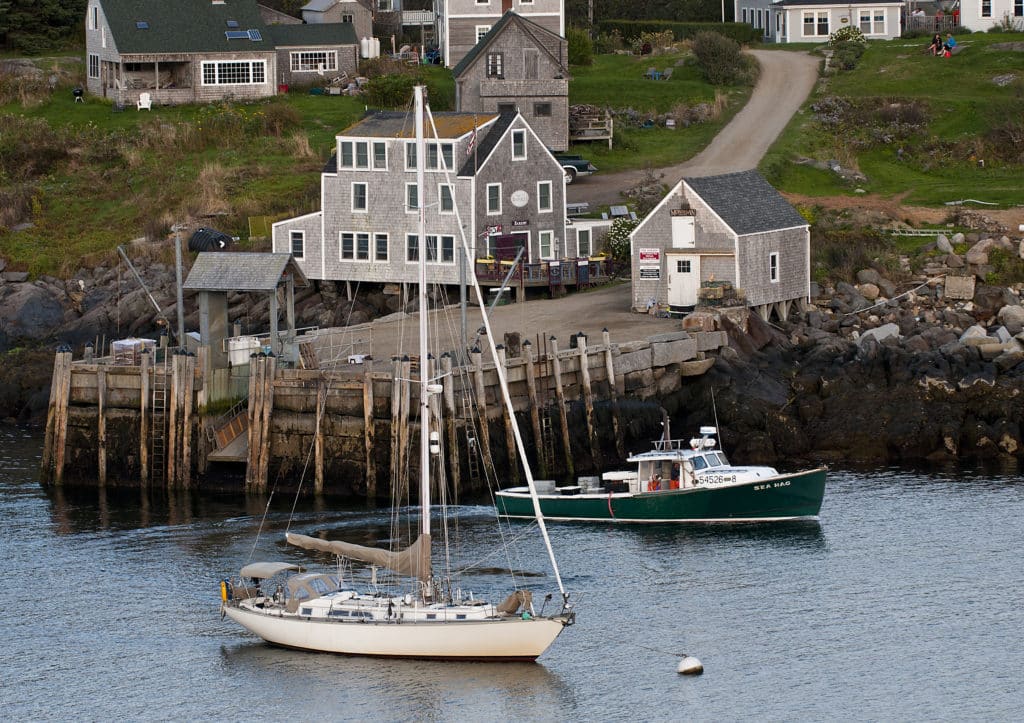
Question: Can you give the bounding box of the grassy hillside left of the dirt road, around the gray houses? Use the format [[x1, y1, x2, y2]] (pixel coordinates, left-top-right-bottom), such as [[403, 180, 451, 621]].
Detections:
[[0, 47, 745, 274]]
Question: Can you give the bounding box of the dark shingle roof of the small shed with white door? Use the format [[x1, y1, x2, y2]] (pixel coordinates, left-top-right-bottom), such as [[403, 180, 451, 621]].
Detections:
[[683, 170, 807, 236]]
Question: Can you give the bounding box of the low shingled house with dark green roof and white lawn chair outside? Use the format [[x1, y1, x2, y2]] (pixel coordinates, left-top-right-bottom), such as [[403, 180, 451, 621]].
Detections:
[[85, 0, 358, 104]]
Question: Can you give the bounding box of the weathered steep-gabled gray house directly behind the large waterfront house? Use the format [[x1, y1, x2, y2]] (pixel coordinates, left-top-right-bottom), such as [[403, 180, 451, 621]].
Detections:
[[452, 11, 569, 151]]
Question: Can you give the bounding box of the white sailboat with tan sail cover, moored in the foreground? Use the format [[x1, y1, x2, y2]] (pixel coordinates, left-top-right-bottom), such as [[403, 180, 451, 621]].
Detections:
[[221, 86, 575, 661]]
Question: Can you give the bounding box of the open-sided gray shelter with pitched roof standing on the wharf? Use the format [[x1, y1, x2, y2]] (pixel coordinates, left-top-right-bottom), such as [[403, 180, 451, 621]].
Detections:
[[184, 251, 309, 369]]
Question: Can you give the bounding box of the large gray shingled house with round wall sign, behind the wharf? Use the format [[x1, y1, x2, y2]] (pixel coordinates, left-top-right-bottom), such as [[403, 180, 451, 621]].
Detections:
[[272, 106, 575, 285]]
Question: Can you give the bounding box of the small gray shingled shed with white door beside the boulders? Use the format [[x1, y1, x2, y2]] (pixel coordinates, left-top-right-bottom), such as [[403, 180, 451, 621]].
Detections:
[[630, 170, 811, 320]]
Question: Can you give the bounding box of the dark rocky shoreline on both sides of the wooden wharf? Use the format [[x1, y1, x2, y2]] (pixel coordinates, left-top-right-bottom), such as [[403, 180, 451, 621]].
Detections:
[[0, 235, 1024, 464]]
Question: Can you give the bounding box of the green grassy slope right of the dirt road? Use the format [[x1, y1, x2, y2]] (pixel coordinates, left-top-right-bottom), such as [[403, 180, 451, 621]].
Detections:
[[761, 34, 1024, 206]]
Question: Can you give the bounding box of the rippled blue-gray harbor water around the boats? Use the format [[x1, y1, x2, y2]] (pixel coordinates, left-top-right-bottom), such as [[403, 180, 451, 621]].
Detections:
[[0, 428, 1024, 721]]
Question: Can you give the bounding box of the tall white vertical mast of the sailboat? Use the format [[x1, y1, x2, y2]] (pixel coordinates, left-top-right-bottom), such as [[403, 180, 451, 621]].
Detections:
[[415, 85, 430, 535]]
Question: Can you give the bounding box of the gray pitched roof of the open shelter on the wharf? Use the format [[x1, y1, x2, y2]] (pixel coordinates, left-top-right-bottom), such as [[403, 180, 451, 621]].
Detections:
[[182, 251, 309, 292]]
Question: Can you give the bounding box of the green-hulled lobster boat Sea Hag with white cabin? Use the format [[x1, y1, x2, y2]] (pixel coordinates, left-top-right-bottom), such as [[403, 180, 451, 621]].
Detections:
[[496, 427, 825, 522]]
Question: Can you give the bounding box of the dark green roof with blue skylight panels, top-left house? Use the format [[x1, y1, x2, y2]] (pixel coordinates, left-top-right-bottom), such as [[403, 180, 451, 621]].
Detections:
[[99, 0, 273, 54]]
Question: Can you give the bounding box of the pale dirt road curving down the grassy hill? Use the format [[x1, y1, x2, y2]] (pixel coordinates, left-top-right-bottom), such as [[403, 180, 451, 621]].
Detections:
[[568, 50, 818, 207]]
